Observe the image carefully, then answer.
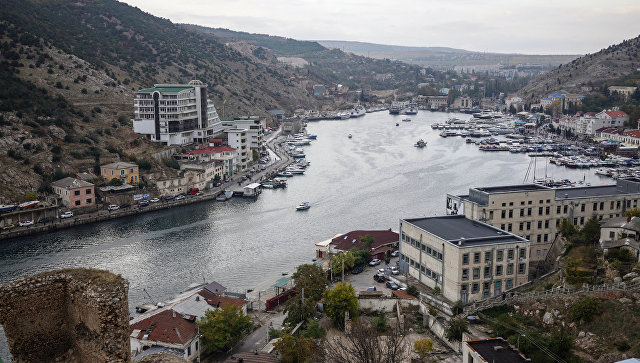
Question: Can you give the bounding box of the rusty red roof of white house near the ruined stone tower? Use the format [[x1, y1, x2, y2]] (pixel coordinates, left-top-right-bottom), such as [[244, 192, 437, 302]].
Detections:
[[129, 310, 198, 344]]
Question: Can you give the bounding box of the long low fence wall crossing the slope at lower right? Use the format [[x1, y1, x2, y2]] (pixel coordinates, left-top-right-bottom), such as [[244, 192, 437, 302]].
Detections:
[[464, 280, 640, 315]]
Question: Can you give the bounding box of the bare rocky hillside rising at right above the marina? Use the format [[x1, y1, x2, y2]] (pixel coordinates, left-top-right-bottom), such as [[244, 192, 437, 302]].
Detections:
[[518, 37, 640, 102]]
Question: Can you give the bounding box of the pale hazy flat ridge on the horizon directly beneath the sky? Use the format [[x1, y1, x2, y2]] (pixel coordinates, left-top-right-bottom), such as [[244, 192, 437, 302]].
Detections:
[[318, 40, 578, 67]]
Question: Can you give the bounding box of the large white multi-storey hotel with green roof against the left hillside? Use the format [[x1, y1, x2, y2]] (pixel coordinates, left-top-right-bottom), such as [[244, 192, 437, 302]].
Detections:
[[133, 80, 222, 145]]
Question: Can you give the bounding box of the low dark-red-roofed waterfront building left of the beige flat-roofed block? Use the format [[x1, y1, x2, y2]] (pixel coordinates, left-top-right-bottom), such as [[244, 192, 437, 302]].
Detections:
[[316, 229, 399, 260]]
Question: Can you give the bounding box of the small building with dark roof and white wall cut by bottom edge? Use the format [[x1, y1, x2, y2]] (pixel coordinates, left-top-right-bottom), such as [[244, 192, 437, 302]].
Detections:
[[462, 338, 531, 363]]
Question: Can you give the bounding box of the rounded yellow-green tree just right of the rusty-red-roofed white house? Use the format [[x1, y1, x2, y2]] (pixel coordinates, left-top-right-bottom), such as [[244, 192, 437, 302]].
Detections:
[[198, 304, 253, 353]]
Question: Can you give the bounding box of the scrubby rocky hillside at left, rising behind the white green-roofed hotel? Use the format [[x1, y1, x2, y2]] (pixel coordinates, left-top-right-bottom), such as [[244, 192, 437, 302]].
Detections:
[[0, 0, 330, 203]]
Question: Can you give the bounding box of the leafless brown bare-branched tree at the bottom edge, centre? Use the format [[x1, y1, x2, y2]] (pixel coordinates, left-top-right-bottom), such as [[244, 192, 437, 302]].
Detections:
[[322, 321, 410, 363]]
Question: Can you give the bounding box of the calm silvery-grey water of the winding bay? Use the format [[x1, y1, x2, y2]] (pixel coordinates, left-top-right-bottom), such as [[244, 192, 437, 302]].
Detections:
[[0, 111, 612, 360]]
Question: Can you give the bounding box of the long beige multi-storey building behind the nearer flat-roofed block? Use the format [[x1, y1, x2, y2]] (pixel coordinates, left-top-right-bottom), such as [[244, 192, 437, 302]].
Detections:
[[446, 178, 640, 269]]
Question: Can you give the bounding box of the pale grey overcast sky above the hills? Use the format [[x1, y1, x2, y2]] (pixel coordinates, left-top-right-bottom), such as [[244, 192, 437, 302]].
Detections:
[[124, 0, 640, 54]]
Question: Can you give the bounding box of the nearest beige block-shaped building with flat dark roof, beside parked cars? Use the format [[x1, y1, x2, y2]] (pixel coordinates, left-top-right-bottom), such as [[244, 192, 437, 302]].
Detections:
[[399, 216, 529, 303]]
